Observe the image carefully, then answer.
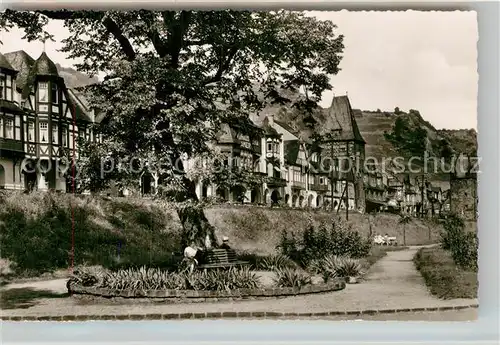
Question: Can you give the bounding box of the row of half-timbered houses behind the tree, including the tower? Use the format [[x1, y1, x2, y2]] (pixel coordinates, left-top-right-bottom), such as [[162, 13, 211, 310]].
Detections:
[[0, 51, 476, 219]]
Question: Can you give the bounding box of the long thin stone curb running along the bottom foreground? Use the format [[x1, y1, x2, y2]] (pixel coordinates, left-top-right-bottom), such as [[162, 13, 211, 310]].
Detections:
[[0, 304, 479, 321]]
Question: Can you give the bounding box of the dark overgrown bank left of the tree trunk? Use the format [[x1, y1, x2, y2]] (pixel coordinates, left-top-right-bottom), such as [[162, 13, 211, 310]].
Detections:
[[0, 193, 180, 276]]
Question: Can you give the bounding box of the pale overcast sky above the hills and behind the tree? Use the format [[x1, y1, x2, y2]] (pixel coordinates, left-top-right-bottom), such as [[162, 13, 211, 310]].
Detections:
[[0, 11, 478, 129]]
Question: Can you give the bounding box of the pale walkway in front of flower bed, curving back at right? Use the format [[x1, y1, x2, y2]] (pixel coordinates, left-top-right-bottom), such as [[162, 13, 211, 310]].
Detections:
[[1, 247, 477, 316]]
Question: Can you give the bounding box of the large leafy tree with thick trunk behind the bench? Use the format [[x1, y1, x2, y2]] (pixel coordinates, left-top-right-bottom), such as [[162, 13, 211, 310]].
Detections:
[[0, 10, 343, 249]]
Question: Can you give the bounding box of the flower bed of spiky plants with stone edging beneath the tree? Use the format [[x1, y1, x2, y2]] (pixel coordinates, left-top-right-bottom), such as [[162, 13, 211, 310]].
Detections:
[[67, 267, 345, 301]]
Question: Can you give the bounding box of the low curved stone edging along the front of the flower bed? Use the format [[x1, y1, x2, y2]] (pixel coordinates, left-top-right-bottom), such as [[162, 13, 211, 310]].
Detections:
[[68, 280, 346, 302]]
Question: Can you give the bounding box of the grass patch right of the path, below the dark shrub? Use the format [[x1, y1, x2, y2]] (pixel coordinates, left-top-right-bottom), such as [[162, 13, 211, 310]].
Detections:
[[413, 247, 478, 299]]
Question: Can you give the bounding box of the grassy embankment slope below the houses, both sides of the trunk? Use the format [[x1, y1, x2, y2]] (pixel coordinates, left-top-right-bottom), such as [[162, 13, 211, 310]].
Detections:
[[0, 191, 439, 275]]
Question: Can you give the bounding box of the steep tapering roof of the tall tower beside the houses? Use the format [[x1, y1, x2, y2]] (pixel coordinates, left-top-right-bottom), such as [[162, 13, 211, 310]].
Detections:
[[322, 96, 365, 143]]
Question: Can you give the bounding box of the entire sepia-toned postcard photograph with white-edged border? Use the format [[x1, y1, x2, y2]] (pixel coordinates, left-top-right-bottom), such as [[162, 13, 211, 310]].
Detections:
[[0, 9, 481, 322]]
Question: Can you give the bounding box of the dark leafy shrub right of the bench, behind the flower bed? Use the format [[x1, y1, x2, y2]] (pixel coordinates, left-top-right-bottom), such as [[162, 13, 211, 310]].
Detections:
[[278, 219, 372, 267]]
